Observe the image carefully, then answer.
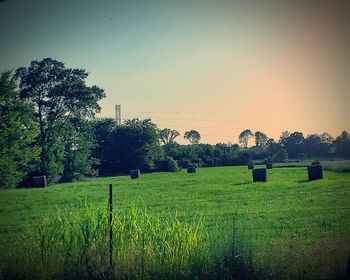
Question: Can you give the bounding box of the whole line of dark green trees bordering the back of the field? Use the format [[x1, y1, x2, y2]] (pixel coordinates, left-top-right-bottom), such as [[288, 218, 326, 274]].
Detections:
[[0, 58, 350, 188]]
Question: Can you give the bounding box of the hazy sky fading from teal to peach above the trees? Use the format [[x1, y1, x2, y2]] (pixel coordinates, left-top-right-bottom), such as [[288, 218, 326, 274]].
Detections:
[[0, 0, 350, 144]]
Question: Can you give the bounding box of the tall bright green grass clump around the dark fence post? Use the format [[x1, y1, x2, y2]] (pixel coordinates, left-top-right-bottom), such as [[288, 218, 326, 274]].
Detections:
[[0, 204, 207, 279]]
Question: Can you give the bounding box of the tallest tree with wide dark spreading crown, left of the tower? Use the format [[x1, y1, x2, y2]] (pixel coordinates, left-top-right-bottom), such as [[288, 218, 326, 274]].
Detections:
[[16, 58, 105, 182]]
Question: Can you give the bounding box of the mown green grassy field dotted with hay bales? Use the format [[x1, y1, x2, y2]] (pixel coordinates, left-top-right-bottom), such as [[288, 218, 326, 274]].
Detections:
[[0, 167, 350, 279]]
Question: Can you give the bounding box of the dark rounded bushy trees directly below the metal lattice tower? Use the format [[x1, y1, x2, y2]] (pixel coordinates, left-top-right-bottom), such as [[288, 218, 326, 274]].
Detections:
[[93, 119, 163, 174]]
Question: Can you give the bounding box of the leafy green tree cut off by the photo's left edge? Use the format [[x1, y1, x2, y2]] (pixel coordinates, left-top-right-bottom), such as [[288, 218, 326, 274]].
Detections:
[[0, 72, 39, 188]]
